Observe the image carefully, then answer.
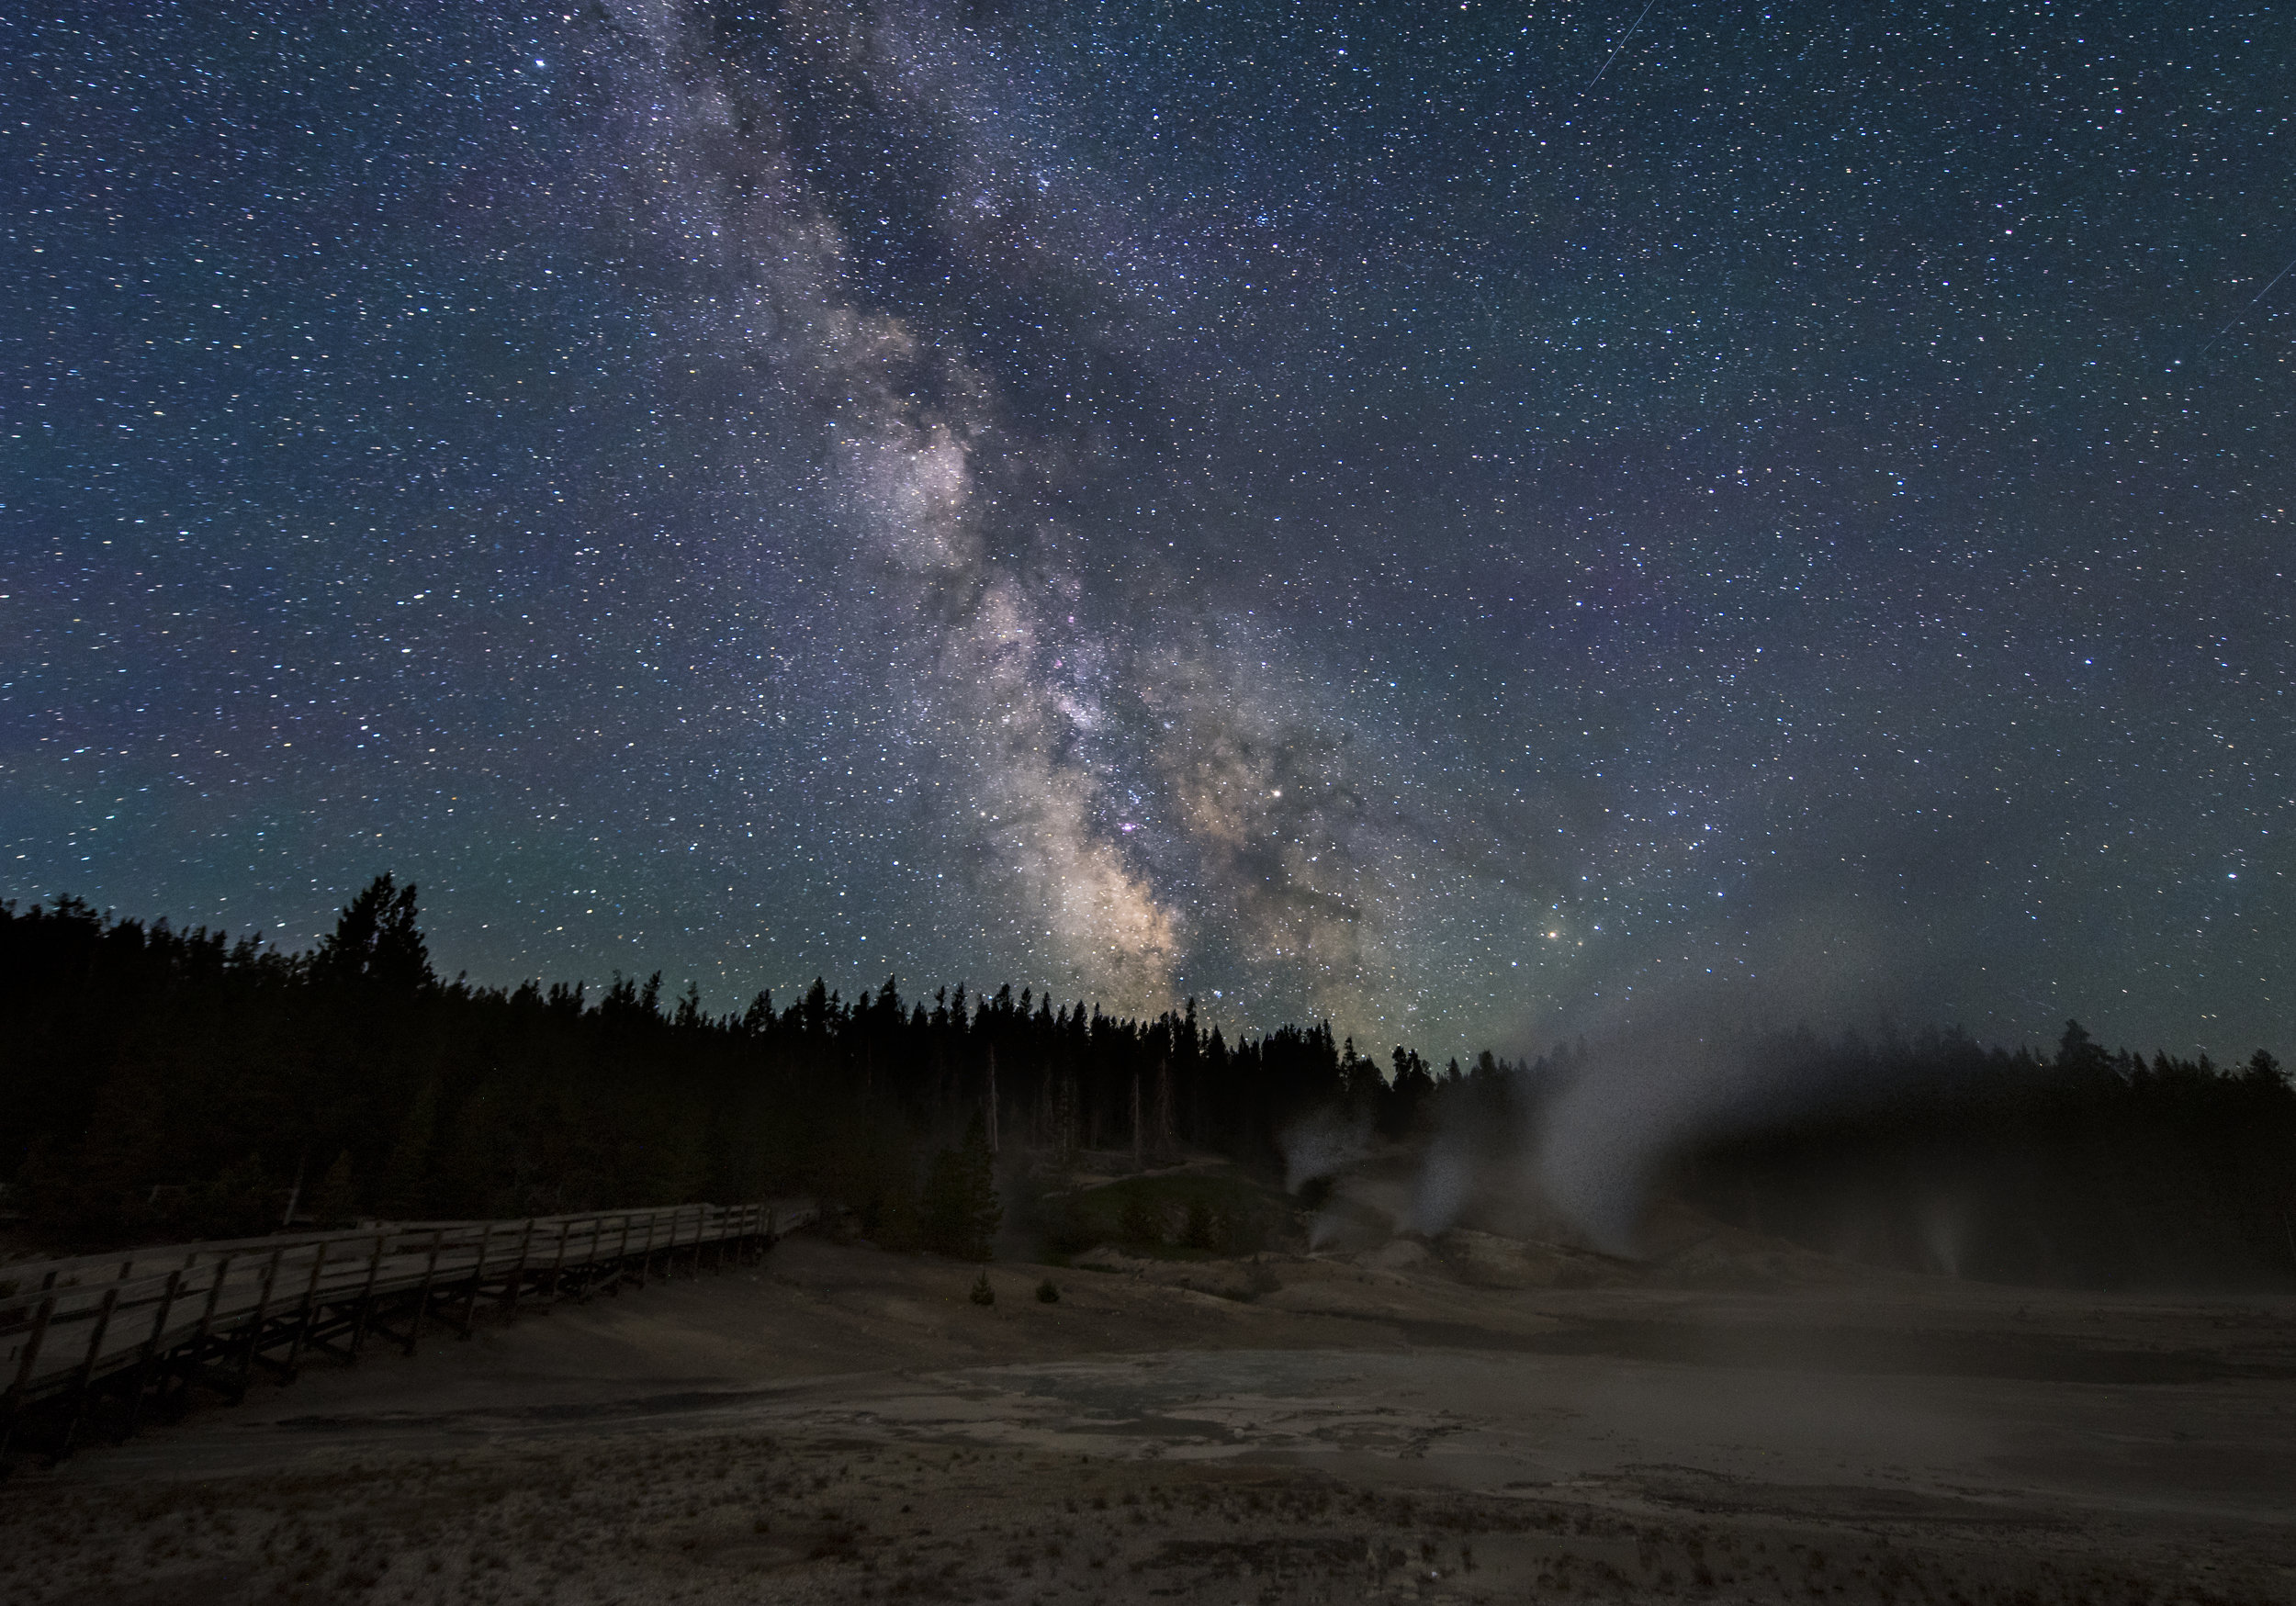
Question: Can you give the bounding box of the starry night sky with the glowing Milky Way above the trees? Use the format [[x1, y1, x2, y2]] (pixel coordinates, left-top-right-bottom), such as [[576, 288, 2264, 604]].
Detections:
[[0, 0, 2296, 1058]]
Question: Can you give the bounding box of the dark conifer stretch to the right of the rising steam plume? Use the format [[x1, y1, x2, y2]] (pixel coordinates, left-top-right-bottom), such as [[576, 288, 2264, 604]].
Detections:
[[1676, 1021, 2296, 1287]]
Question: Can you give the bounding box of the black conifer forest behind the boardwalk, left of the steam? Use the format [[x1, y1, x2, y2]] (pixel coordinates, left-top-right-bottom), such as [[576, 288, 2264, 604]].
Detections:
[[0, 876, 1433, 1251]]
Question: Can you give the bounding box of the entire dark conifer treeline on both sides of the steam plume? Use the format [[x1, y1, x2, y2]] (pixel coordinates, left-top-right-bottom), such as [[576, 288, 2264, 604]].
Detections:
[[0, 876, 2296, 1285]]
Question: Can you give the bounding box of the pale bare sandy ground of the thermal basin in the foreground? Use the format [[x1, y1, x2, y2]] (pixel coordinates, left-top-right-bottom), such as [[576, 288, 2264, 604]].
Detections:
[[0, 1239, 2296, 1606]]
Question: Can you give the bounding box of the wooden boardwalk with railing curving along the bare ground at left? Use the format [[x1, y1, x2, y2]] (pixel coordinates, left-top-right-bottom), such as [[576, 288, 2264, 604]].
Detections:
[[0, 1200, 816, 1466]]
